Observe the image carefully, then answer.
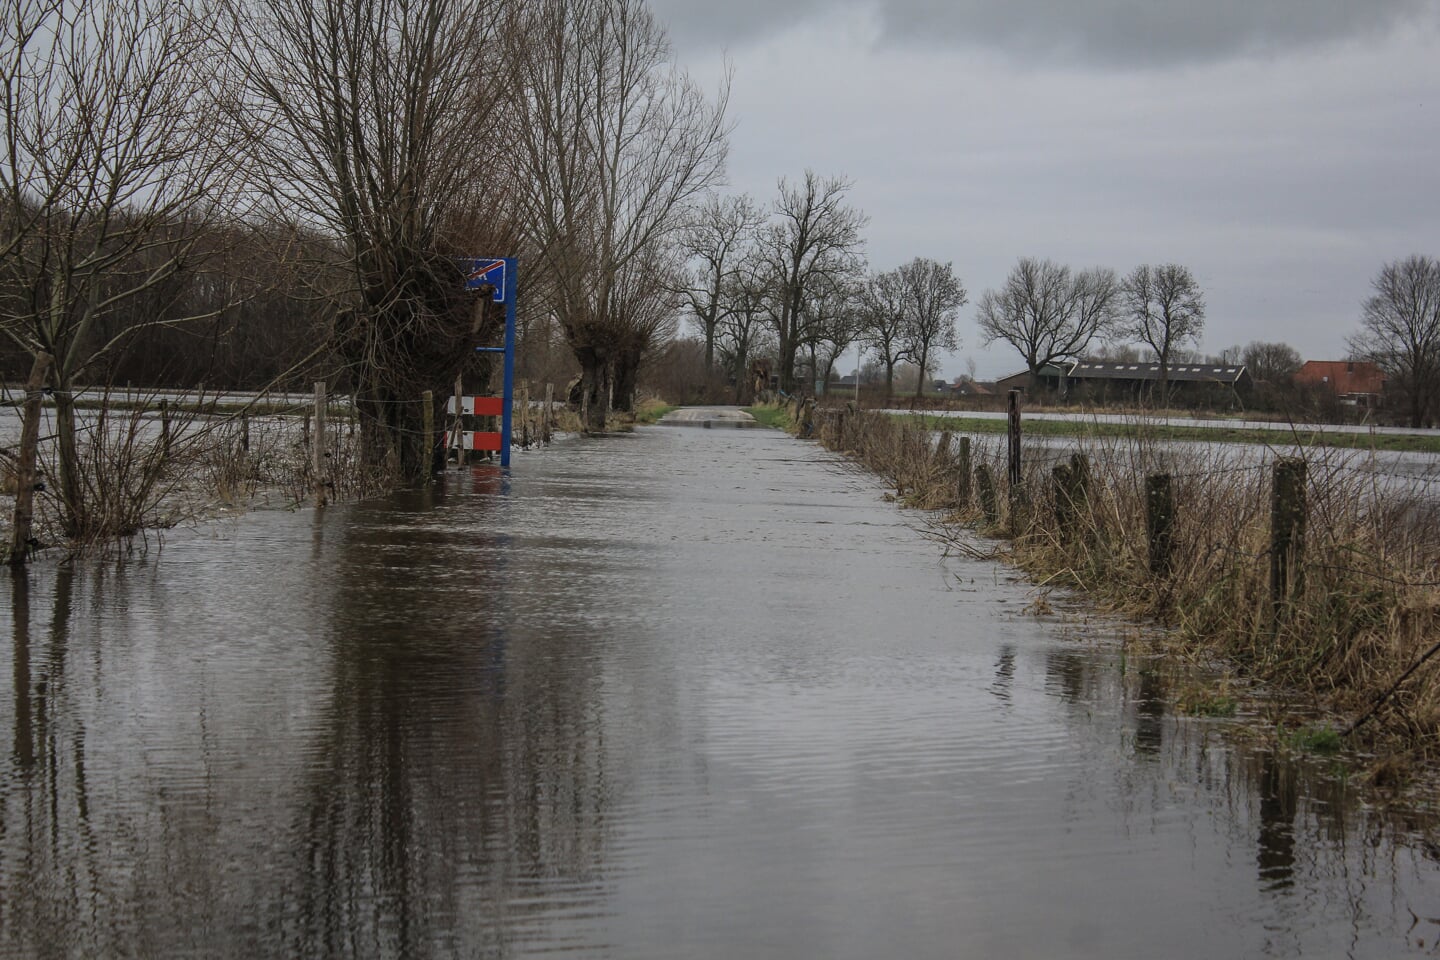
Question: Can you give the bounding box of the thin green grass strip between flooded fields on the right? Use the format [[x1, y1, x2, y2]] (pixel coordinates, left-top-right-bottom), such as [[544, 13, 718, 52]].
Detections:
[[923, 415, 1440, 453]]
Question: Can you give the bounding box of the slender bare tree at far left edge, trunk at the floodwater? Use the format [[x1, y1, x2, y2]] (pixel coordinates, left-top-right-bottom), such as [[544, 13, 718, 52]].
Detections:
[[0, 0, 236, 540]]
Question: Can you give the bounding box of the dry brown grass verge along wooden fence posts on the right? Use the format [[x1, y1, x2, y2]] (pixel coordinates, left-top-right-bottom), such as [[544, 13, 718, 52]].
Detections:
[[819, 410, 1440, 783]]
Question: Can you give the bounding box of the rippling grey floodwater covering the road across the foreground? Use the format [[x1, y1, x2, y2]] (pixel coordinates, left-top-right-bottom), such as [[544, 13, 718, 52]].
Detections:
[[0, 427, 1440, 959]]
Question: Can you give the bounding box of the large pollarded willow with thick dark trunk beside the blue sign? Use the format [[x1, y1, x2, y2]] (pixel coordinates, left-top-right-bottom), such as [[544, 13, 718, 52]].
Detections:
[[223, 0, 514, 479]]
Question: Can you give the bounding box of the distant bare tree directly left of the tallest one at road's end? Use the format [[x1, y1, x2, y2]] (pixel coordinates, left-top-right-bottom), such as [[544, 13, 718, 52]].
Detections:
[[680, 194, 763, 373]]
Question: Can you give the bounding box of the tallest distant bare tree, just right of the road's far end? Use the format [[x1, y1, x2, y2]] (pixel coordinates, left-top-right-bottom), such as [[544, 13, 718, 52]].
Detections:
[[762, 170, 868, 390]]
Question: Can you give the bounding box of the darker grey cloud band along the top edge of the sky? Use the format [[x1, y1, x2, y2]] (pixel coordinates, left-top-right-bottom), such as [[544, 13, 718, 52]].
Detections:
[[652, 0, 1440, 68]]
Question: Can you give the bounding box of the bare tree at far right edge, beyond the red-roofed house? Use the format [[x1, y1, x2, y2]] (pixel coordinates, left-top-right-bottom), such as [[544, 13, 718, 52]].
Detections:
[[1349, 255, 1440, 426]]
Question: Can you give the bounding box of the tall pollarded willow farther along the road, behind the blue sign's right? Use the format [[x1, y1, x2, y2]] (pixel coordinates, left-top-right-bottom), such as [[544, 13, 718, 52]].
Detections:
[[501, 0, 729, 432]]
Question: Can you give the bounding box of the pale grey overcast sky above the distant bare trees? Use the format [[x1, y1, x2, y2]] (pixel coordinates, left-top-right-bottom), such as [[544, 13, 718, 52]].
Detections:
[[651, 0, 1440, 379]]
